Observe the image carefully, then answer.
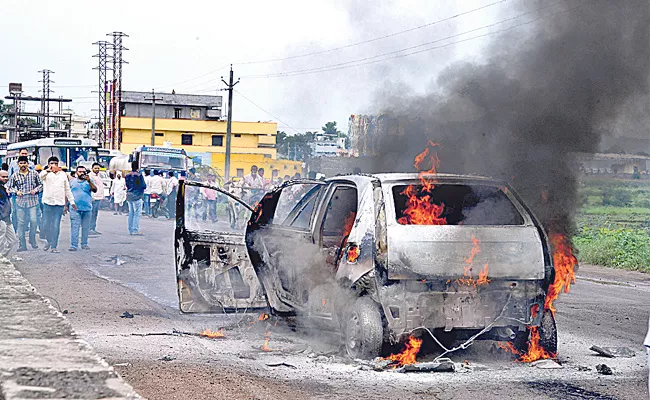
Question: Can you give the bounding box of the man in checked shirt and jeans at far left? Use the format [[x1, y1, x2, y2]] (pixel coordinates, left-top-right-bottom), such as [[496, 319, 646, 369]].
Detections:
[[7, 156, 43, 251]]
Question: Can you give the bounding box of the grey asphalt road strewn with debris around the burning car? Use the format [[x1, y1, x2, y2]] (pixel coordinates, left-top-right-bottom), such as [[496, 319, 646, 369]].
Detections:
[[11, 212, 650, 400]]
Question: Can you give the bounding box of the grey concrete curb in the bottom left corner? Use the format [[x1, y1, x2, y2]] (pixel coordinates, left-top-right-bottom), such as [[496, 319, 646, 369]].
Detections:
[[0, 263, 142, 400]]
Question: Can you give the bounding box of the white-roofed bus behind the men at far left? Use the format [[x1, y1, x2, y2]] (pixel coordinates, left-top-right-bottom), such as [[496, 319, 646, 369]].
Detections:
[[5, 137, 99, 169]]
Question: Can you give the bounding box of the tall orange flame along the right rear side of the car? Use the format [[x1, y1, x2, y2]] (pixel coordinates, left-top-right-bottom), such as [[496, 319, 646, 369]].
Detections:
[[544, 233, 578, 315]]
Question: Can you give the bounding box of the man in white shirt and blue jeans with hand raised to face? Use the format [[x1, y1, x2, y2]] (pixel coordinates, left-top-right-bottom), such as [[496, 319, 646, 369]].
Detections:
[[41, 157, 77, 253]]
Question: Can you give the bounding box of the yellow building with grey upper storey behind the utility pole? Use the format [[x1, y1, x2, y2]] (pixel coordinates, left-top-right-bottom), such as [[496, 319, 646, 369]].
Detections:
[[120, 92, 302, 178]]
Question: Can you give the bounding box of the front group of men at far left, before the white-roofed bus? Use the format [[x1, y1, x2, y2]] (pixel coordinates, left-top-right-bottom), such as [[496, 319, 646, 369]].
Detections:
[[0, 149, 103, 262]]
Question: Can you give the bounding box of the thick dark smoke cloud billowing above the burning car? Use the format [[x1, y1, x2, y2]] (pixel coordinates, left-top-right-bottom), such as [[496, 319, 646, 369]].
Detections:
[[373, 0, 650, 233]]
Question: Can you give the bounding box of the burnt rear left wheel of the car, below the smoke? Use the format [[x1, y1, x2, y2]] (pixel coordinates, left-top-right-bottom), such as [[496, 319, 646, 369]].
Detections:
[[343, 297, 384, 359]]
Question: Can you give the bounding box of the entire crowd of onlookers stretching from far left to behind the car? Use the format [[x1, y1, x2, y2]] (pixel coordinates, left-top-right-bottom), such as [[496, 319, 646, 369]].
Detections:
[[0, 149, 308, 262]]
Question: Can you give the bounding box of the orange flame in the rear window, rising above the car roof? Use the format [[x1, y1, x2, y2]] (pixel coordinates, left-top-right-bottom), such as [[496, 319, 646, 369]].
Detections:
[[397, 141, 447, 225]]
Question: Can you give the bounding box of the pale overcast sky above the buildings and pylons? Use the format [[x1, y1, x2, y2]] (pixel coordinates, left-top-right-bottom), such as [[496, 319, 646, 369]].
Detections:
[[0, 0, 525, 133]]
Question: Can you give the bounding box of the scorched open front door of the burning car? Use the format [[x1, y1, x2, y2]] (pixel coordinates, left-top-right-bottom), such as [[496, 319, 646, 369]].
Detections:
[[174, 181, 267, 313]]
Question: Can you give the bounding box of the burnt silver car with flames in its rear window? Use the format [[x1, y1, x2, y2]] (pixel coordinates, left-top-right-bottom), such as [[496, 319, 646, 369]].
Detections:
[[177, 174, 557, 358]]
